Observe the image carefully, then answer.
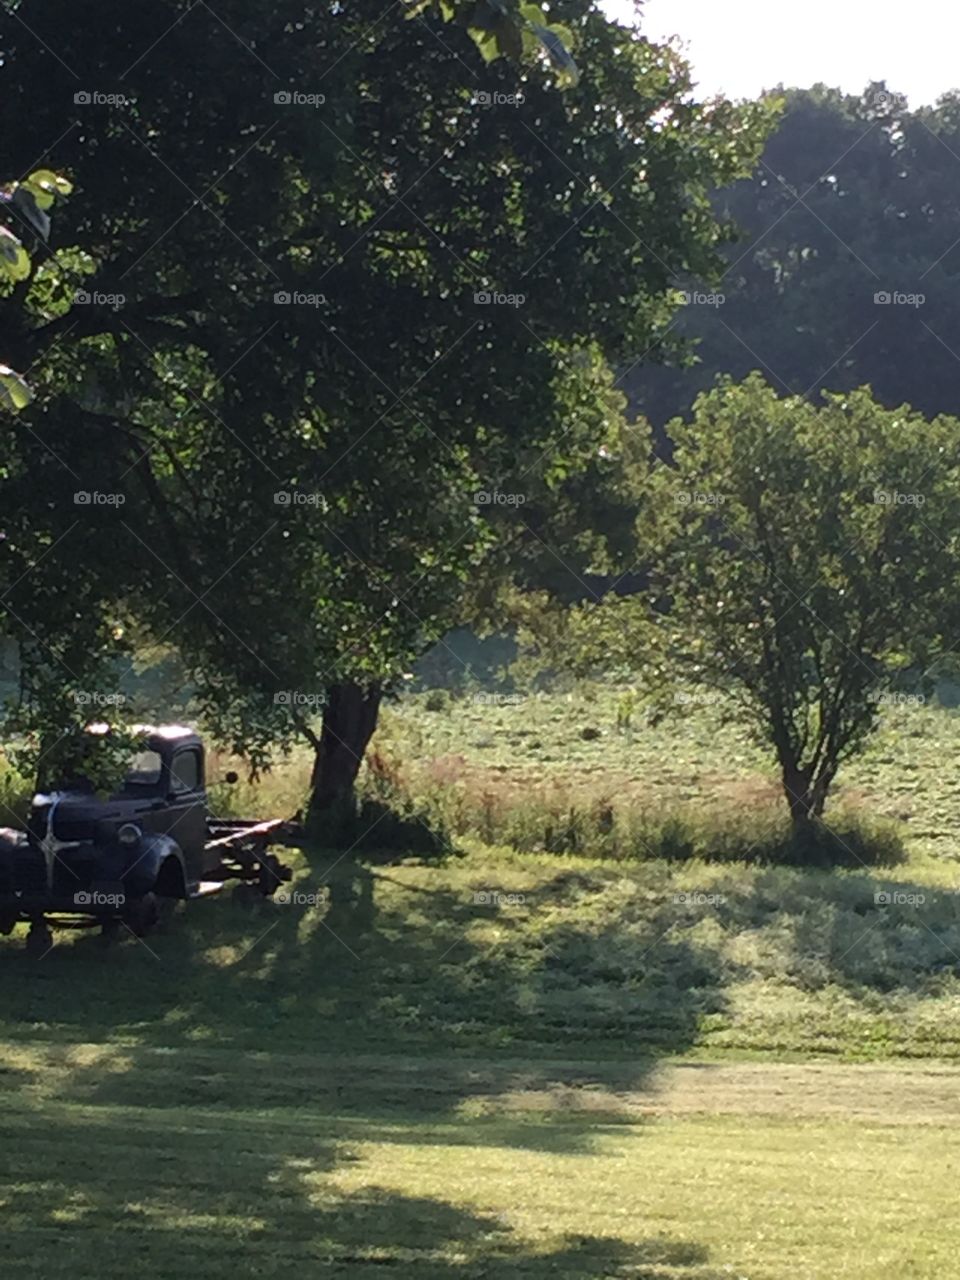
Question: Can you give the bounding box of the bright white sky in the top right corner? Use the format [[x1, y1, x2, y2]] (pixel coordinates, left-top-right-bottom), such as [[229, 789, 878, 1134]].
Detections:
[[604, 0, 960, 108]]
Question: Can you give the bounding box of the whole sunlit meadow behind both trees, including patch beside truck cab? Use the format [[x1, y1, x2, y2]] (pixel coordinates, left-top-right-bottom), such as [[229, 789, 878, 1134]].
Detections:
[[212, 684, 960, 868]]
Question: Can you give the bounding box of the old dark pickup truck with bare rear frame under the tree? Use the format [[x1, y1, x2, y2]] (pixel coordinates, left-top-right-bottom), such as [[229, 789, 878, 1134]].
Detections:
[[0, 726, 291, 954]]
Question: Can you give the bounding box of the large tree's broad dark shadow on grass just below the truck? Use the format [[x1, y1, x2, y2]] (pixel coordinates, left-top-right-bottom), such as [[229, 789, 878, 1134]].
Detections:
[[3, 858, 709, 1152]]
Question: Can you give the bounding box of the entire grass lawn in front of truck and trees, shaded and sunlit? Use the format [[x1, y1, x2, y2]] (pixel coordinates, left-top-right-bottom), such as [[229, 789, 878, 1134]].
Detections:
[[0, 846, 960, 1280]]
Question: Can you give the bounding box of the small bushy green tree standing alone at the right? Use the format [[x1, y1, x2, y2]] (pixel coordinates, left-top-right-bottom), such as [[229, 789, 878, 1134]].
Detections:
[[652, 374, 960, 827]]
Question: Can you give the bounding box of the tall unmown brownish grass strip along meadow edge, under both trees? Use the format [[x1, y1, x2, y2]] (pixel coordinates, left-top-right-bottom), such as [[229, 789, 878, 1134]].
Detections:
[[200, 694, 905, 868]]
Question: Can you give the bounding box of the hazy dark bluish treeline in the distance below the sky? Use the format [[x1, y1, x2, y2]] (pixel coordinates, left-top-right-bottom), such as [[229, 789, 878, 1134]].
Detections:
[[620, 84, 960, 440]]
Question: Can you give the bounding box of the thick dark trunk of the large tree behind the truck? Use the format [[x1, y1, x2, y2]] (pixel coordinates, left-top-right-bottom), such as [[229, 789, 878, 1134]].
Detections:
[[308, 684, 383, 820]]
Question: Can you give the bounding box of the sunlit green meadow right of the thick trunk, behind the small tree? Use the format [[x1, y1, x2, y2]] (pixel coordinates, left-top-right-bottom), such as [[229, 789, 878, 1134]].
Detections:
[[376, 685, 960, 860]]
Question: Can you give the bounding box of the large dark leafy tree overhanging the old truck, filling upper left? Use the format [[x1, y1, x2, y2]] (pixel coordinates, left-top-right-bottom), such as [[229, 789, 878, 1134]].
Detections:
[[0, 0, 765, 819]]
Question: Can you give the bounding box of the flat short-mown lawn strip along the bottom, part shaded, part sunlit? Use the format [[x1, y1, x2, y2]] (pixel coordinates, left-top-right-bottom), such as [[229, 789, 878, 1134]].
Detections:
[[0, 1046, 960, 1280]]
